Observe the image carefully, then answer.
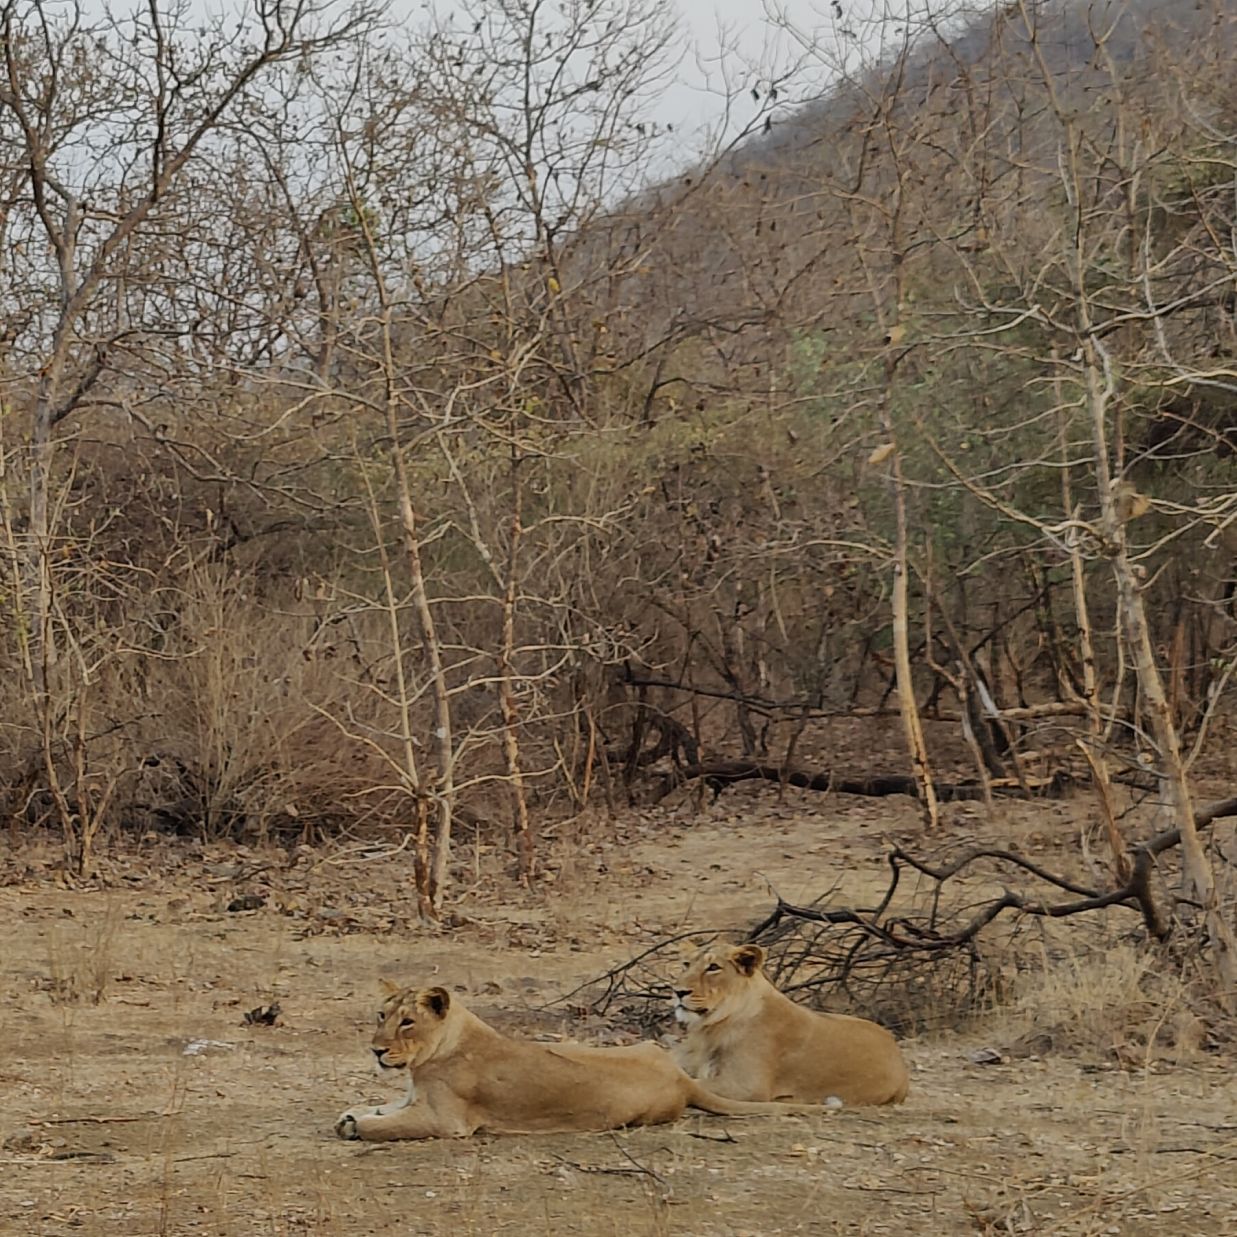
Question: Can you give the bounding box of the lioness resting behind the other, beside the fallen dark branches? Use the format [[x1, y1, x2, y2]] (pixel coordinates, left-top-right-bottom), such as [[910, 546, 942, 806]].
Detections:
[[674, 945, 908, 1105]]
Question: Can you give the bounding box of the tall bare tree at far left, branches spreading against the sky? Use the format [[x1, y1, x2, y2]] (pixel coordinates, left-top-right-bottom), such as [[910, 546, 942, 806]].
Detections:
[[0, 0, 374, 865]]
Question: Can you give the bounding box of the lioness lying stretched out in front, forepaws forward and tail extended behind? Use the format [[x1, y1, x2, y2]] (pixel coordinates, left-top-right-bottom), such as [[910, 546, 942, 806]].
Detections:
[[335, 981, 821, 1142]]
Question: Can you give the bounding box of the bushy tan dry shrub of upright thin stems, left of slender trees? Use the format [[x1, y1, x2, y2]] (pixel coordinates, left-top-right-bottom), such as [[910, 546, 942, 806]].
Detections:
[[134, 570, 391, 839]]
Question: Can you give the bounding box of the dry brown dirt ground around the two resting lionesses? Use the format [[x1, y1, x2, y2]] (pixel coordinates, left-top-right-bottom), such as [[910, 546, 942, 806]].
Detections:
[[0, 789, 1237, 1237]]
